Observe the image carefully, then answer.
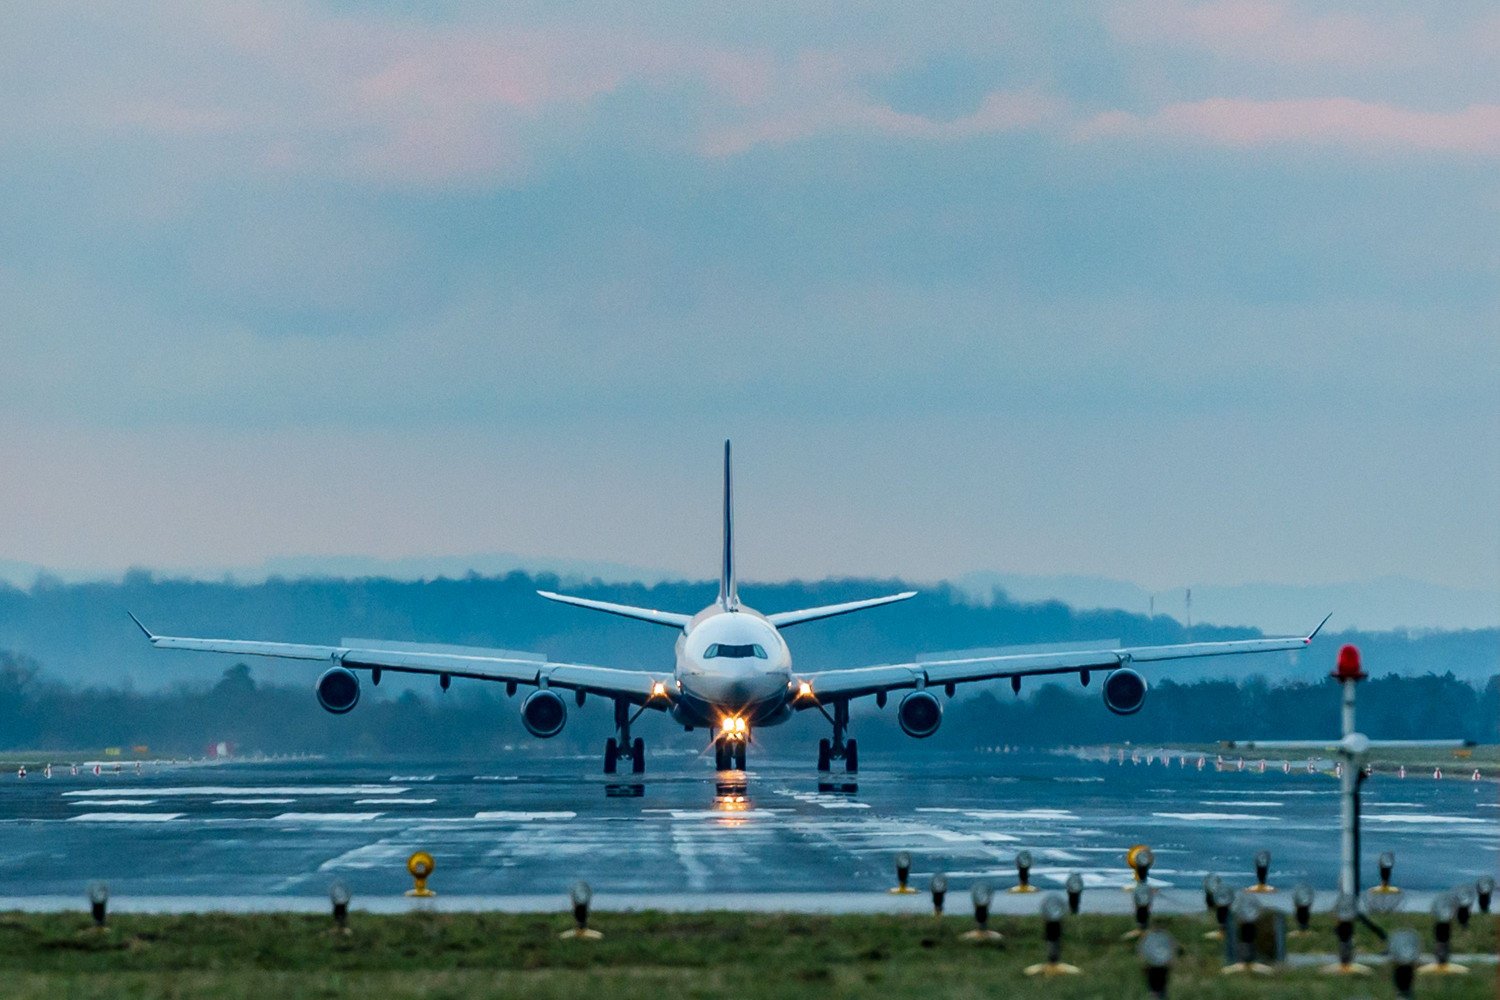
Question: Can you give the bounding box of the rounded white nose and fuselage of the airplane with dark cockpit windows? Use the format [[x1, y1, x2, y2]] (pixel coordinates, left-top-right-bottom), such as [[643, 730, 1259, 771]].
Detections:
[[674, 604, 792, 726]]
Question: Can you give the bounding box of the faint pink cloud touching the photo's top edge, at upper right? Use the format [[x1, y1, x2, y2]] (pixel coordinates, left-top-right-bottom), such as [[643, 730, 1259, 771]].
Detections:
[[1107, 0, 1427, 66]]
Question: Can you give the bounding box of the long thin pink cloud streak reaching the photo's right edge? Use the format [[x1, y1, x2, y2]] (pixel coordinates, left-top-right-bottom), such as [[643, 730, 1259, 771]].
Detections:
[[1076, 97, 1500, 156]]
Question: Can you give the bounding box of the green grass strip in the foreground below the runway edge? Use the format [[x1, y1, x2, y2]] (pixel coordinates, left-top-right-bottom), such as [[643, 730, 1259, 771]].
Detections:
[[0, 913, 1496, 1000]]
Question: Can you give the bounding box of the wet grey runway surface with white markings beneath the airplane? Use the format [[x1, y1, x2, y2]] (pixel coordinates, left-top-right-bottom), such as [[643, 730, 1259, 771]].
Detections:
[[0, 753, 1500, 898]]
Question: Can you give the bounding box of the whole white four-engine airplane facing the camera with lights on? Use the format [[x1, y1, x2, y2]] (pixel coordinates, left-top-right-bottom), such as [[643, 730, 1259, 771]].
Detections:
[[131, 441, 1328, 774]]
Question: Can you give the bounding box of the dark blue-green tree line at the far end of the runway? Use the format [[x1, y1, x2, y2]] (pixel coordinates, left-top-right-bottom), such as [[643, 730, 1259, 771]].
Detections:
[[0, 654, 1500, 759]]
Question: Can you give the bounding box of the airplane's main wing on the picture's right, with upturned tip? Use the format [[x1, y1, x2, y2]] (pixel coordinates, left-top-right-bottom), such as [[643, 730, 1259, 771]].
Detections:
[[797, 618, 1328, 708]]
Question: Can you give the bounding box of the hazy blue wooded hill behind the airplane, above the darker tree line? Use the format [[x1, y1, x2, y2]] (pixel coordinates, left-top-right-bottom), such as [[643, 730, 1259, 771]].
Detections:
[[0, 571, 1500, 690]]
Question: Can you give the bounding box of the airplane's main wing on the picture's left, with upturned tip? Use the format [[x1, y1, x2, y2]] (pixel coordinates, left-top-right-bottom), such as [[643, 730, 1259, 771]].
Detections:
[[131, 615, 675, 709]]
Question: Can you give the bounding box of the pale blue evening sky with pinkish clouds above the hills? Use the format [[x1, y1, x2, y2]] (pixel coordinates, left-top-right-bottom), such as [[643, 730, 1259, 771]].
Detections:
[[0, 0, 1500, 602]]
